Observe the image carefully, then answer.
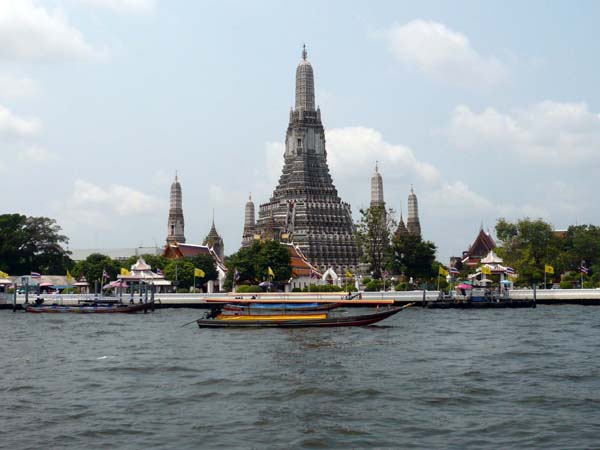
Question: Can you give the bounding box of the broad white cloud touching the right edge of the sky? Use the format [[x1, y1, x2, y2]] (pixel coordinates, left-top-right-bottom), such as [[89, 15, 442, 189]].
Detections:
[[446, 101, 600, 165]]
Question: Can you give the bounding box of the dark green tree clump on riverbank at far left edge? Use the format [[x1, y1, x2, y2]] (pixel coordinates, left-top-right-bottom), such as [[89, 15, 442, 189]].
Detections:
[[0, 214, 72, 275]]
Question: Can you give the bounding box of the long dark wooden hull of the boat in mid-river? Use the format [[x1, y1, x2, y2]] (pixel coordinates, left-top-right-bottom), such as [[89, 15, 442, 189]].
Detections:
[[196, 306, 406, 328]]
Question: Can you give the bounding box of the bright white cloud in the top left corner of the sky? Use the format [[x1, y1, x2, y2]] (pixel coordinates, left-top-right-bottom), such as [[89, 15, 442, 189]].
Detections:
[[0, 0, 97, 61]]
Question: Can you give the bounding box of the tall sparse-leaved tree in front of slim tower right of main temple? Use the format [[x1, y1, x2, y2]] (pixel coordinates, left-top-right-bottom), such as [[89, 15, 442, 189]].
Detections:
[[355, 206, 396, 278]]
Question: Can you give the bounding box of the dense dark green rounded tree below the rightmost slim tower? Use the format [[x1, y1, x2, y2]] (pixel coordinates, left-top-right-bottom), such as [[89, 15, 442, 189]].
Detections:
[[392, 234, 437, 282]]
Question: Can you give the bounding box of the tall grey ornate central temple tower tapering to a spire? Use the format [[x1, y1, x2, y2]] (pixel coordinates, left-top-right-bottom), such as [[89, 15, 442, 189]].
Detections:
[[255, 47, 358, 275]]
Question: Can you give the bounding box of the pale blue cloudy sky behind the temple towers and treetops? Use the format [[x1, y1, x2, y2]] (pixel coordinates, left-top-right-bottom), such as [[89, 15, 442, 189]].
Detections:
[[0, 0, 600, 262]]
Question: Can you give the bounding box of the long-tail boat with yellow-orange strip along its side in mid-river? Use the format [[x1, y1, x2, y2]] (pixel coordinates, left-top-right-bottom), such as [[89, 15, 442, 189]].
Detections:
[[196, 304, 412, 328]]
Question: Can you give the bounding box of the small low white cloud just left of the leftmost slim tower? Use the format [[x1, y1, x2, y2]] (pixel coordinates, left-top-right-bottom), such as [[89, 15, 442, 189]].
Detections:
[[72, 179, 164, 216]]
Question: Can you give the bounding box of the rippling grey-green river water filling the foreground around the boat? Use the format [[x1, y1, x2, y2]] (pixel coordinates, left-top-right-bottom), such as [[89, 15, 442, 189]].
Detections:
[[0, 306, 600, 449]]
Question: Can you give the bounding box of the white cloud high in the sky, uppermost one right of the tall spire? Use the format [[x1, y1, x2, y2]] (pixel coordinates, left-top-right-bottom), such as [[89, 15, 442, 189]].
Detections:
[[379, 20, 508, 87]]
